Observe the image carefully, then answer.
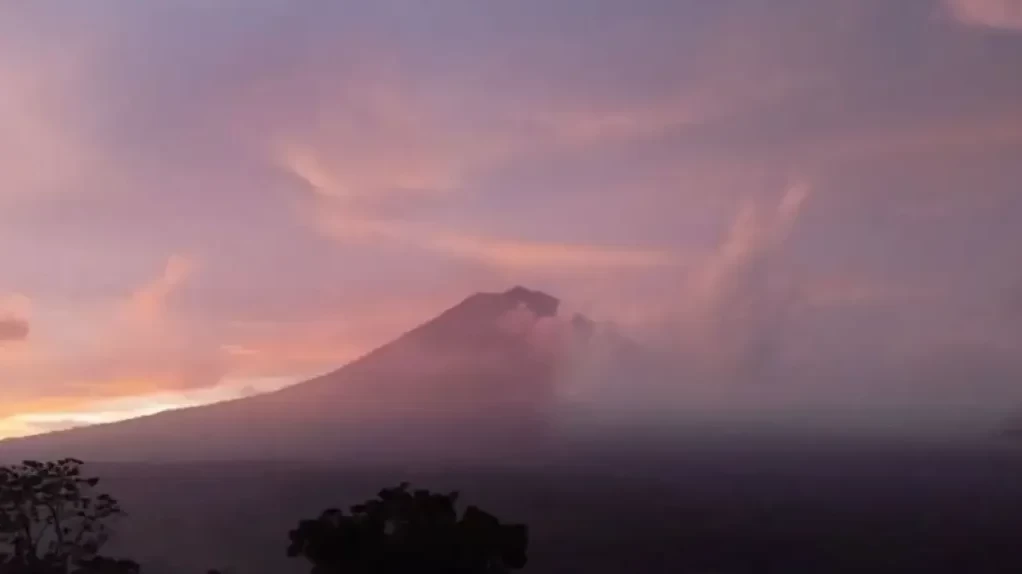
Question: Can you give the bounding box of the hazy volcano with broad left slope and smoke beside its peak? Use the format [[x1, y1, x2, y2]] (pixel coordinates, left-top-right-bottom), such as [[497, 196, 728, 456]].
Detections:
[[0, 287, 593, 461]]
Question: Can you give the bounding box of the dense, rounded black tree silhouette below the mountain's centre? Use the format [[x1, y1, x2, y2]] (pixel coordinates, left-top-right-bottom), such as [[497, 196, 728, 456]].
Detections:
[[287, 483, 528, 574]]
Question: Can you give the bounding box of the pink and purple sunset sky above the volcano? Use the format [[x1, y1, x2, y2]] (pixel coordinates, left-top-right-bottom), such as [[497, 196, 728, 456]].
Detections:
[[0, 0, 1022, 437]]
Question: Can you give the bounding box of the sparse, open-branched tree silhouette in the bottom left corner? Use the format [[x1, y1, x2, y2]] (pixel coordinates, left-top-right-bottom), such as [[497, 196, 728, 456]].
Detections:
[[0, 459, 139, 574]]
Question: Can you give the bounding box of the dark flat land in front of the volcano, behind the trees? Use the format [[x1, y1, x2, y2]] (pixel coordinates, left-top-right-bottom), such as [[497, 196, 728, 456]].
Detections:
[[92, 435, 1022, 574]]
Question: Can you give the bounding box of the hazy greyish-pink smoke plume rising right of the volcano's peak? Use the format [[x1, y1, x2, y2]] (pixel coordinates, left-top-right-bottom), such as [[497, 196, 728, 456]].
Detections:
[[539, 183, 1022, 437]]
